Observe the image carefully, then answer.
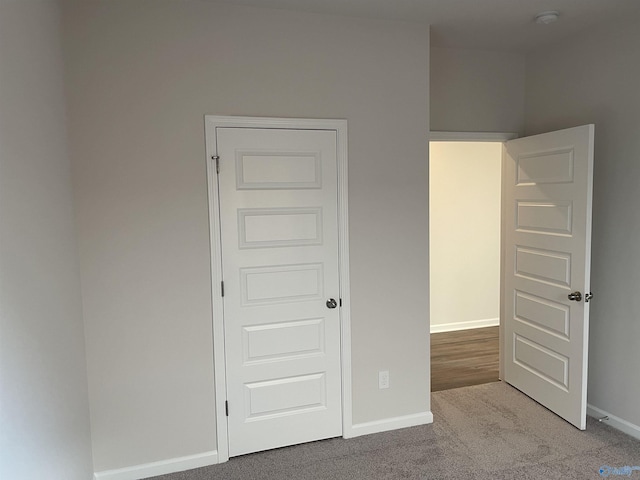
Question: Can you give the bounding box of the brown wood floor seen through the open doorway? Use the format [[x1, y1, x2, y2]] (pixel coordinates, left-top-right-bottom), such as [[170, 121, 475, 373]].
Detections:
[[431, 327, 499, 392]]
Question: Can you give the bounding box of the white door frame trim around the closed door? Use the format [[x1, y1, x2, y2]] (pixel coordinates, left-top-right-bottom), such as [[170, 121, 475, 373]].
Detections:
[[204, 115, 353, 463]]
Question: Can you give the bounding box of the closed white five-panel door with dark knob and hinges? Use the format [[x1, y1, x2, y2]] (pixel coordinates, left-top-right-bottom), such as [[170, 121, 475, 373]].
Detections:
[[216, 128, 342, 456]]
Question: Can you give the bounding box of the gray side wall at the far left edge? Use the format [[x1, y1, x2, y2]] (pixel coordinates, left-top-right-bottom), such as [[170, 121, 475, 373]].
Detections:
[[0, 0, 92, 480]]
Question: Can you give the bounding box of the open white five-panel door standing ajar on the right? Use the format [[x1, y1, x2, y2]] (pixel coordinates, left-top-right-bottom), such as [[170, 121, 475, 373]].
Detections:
[[502, 125, 594, 430]]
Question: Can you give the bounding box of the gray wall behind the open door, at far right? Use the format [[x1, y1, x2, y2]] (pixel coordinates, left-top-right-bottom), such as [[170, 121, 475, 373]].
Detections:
[[526, 16, 640, 425]]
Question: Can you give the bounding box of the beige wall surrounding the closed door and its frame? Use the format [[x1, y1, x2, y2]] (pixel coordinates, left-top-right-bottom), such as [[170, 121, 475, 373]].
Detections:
[[64, 0, 430, 471]]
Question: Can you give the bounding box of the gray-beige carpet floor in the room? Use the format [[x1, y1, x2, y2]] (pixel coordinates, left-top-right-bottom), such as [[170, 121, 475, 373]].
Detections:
[[154, 382, 640, 480]]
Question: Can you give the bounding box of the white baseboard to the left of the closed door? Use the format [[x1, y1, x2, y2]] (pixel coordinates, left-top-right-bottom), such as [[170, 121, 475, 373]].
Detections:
[[93, 450, 218, 480]]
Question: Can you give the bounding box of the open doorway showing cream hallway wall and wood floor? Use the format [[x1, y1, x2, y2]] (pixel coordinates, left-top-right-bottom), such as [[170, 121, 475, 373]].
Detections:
[[429, 132, 514, 392]]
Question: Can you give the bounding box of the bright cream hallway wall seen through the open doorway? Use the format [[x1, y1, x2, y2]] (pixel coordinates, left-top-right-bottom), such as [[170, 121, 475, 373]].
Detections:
[[429, 142, 502, 331]]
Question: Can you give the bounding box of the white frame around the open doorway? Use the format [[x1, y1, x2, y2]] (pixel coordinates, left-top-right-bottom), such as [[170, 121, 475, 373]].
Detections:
[[429, 131, 520, 380]]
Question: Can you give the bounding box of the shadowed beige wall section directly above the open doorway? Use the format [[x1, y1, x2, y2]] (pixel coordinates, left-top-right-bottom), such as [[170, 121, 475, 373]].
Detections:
[[430, 48, 525, 133]]
